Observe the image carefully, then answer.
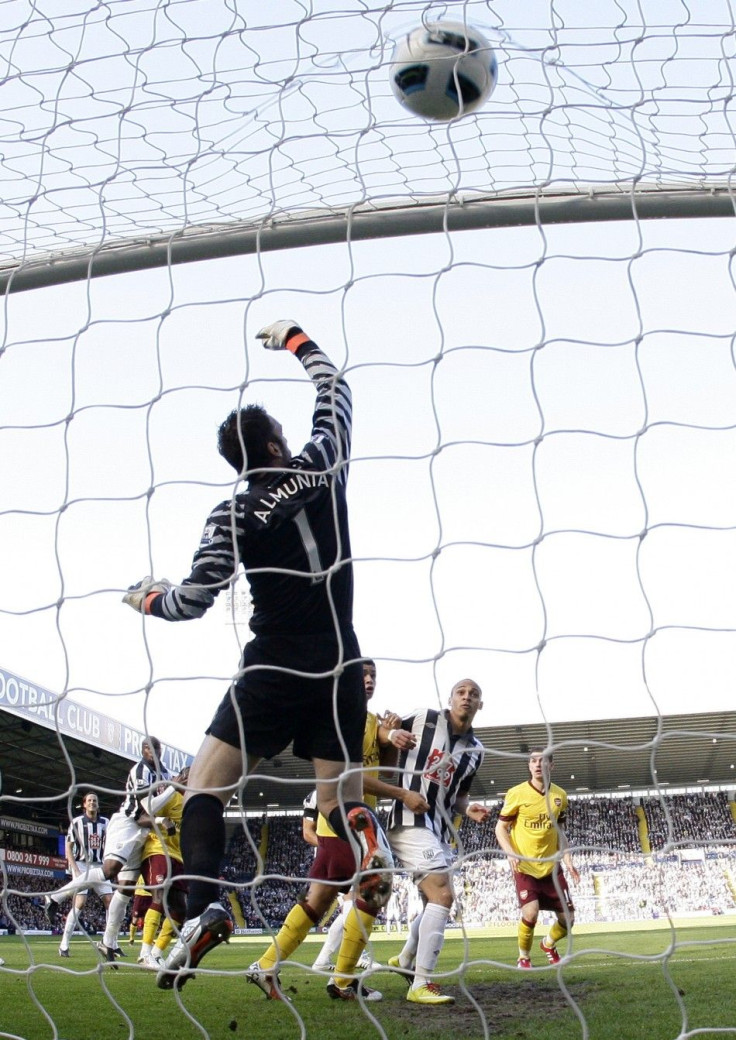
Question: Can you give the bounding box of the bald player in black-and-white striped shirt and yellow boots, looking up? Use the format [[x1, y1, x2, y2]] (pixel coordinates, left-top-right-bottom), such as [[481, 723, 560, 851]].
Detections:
[[389, 679, 489, 1005]]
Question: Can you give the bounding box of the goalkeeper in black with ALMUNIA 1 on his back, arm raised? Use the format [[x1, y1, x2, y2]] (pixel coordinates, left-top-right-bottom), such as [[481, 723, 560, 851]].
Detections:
[[124, 320, 393, 989]]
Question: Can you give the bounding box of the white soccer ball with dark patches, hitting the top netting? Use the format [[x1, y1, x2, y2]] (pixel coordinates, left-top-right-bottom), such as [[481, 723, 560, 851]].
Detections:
[[391, 22, 498, 122]]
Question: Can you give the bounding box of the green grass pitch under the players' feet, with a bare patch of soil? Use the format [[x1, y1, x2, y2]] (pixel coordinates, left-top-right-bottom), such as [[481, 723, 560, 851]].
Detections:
[[0, 918, 736, 1040]]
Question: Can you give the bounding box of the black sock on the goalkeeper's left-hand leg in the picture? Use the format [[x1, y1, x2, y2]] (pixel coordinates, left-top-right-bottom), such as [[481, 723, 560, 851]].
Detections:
[[181, 795, 226, 920]]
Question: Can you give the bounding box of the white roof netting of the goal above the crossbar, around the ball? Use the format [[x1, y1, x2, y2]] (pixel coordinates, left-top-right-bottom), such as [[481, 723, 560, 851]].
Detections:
[[0, 0, 735, 272]]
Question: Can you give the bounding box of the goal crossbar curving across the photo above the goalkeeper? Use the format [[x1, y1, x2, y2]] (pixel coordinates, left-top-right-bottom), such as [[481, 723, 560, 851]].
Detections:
[[0, 184, 736, 293]]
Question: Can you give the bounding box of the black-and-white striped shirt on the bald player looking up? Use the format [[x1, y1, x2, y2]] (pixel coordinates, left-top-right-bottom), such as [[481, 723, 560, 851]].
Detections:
[[389, 708, 483, 842]]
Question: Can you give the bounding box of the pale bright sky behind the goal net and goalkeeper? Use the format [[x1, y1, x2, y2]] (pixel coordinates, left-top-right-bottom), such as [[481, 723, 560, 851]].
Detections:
[[0, 0, 736, 751]]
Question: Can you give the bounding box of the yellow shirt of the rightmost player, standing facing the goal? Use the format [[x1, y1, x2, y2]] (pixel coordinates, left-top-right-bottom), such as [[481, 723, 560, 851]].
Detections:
[[499, 780, 568, 878]]
